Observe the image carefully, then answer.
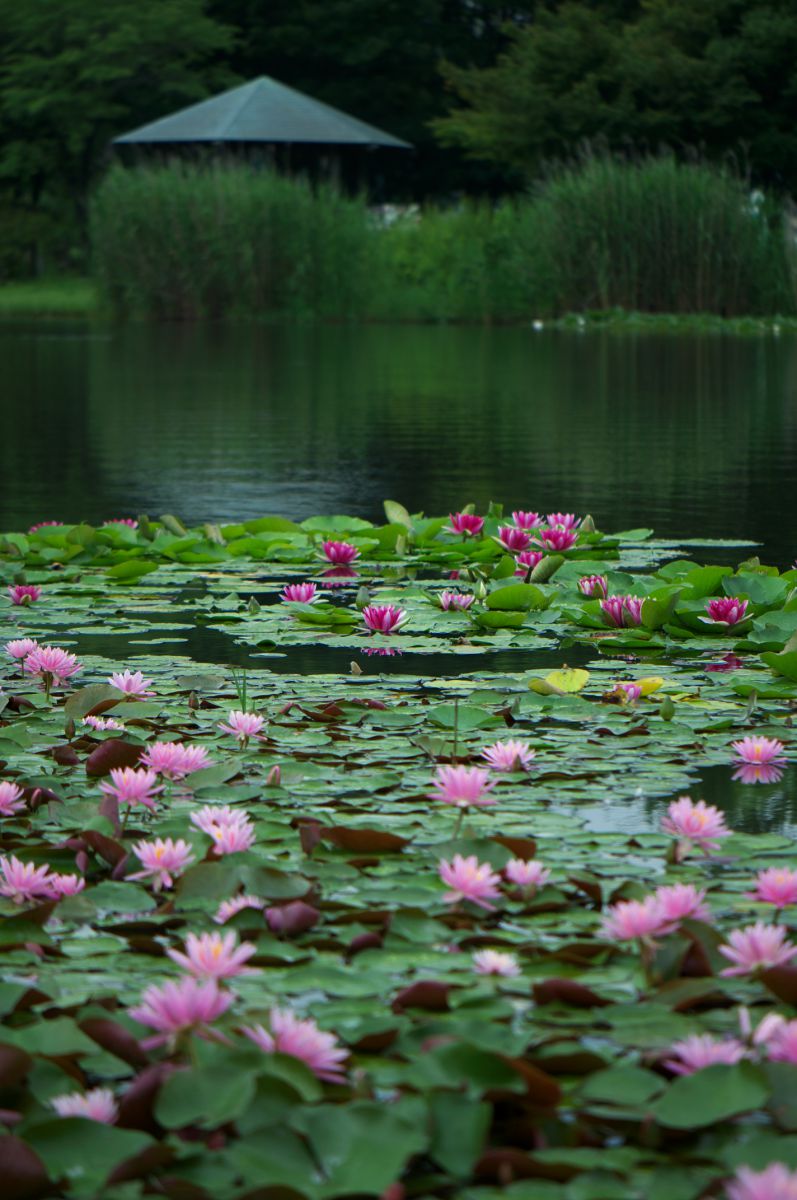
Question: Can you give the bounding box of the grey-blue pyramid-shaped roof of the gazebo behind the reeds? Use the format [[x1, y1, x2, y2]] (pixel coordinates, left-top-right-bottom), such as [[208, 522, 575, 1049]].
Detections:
[[113, 76, 412, 150]]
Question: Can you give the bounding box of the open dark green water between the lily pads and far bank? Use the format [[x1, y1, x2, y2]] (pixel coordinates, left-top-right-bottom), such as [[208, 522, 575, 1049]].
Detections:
[[0, 322, 797, 566]]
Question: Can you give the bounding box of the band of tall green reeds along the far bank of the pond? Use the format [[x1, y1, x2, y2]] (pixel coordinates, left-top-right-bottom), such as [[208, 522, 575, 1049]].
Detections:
[[90, 156, 797, 322]]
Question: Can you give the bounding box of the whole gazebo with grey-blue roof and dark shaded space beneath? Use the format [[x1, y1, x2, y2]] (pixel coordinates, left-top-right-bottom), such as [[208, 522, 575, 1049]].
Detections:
[[113, 76, 413, 193]]
